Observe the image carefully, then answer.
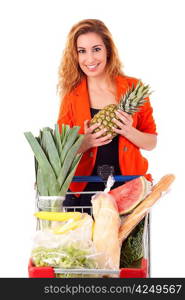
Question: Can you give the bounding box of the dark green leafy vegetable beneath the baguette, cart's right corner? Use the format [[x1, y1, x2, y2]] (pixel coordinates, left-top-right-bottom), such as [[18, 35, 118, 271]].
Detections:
[[120, 219, 145, 268]]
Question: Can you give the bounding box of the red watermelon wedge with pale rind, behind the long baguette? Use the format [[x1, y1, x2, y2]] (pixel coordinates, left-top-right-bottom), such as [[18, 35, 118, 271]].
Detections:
[[109, 176, 151, 215]]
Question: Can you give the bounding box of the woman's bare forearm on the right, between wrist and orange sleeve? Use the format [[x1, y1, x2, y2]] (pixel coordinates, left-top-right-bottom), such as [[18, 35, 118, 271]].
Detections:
[[126, 127, 157, 150]]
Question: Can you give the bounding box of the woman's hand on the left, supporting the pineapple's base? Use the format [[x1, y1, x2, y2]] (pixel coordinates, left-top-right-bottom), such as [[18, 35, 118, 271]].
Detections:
[[78, 120, 112, 152]]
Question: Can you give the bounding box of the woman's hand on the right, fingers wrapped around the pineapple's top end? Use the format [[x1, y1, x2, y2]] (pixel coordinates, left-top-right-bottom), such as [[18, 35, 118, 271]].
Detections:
[[113, 110, 133, 137]]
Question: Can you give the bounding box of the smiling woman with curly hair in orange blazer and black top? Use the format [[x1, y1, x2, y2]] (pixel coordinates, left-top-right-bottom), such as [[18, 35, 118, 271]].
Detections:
[[58, 19, 157, 206]]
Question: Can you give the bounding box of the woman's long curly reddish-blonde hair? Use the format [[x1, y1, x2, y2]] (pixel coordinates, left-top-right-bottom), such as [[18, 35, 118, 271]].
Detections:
[[57, 19, 123, 96]]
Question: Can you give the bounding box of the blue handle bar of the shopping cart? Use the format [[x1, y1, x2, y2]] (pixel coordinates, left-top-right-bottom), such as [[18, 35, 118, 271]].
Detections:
[[72, 175, 140, 182]]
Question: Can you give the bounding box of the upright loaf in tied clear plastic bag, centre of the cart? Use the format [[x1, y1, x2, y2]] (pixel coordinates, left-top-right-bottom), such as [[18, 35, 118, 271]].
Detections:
[[91, 177, 121, 270]]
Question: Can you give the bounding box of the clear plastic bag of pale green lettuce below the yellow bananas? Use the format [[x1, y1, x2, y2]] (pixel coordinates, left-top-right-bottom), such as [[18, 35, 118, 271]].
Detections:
[[31, 213, 102, 269]]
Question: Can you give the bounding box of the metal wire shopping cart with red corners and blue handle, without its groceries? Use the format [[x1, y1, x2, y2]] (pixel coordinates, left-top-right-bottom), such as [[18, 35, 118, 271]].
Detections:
[[28, 176, 150, 278]]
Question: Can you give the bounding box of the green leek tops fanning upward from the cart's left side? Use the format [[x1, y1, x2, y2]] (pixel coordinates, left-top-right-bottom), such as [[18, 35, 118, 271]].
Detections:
[[24, 124, 84, 202]]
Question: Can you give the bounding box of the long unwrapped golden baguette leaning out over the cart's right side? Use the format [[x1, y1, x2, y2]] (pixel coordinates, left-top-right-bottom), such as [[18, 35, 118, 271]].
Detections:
[[119, 174, 175, 244]]
